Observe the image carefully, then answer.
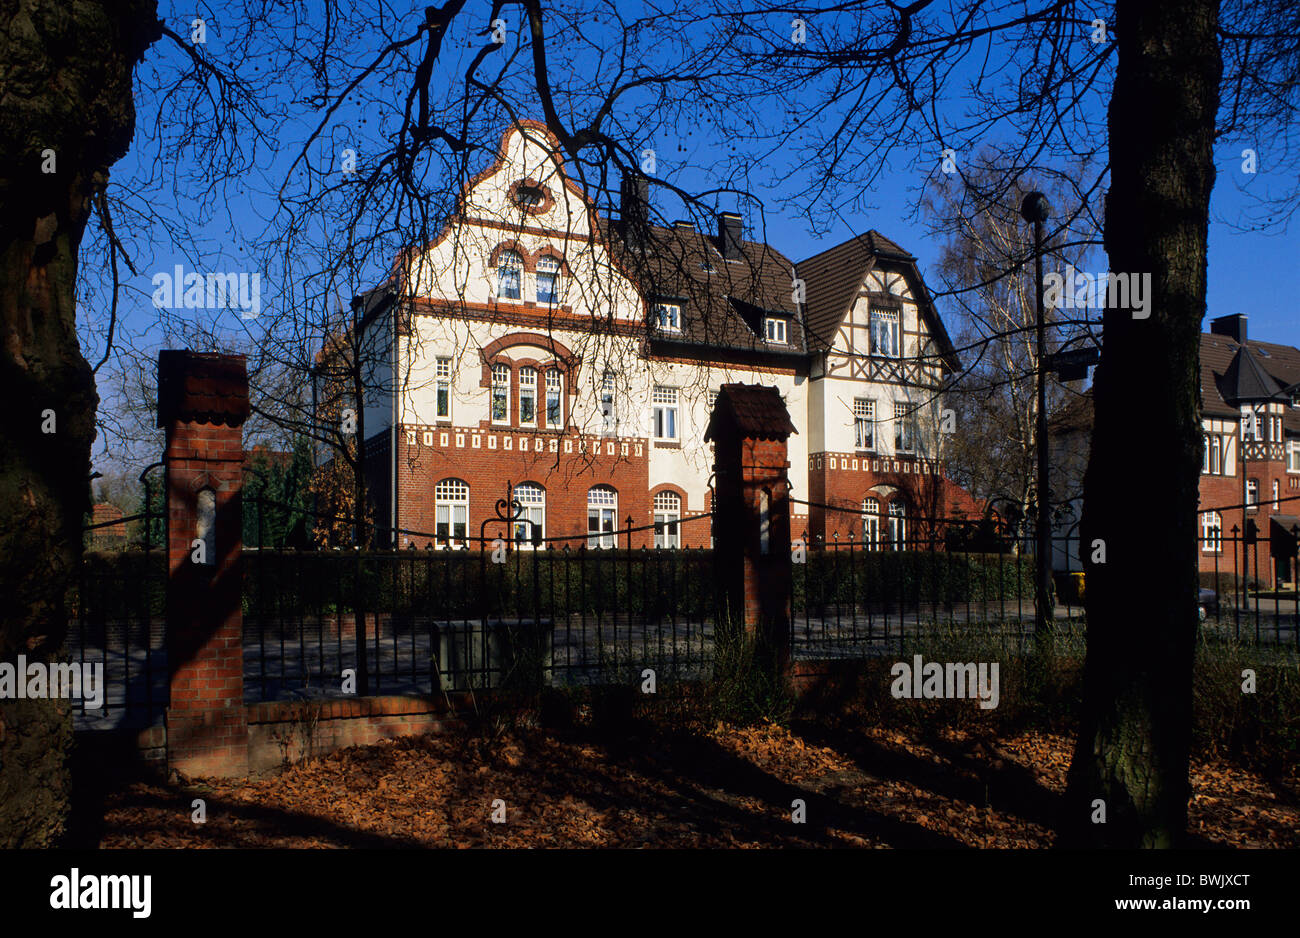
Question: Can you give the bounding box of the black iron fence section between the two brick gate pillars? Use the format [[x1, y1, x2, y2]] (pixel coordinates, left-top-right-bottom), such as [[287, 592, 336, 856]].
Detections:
[[244, 504, 718, 699]]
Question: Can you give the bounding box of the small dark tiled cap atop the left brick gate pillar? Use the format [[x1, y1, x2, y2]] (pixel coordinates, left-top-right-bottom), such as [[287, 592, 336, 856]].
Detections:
[[157, 348, 250, 426]]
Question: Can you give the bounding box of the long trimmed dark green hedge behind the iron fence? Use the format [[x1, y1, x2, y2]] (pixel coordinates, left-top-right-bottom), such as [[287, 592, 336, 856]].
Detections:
[[72, 548, 1034, 621]]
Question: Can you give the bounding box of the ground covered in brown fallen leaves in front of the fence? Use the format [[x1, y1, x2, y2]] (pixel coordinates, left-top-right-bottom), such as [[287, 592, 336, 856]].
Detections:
[[82, 724, 1300, 848]]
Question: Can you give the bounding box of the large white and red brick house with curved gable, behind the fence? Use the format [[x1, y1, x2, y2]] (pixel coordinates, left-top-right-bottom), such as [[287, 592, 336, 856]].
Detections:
[[343, 121, 979, 547]]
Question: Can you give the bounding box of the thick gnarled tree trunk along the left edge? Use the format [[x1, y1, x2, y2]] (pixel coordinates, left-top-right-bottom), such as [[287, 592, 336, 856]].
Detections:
[[0, 0, 160, 847]]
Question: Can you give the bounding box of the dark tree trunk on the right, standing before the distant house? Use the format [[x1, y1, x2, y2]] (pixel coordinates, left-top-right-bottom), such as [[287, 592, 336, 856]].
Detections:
[[1061, 0, 1222, 847]]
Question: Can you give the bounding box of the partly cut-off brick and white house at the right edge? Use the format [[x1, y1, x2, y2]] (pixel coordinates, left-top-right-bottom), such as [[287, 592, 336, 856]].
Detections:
[[1200, 314, 1300, 585]]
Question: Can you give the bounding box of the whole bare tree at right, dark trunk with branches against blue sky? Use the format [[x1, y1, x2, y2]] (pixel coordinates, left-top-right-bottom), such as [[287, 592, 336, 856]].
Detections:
[[731, 0, 1297, 847]]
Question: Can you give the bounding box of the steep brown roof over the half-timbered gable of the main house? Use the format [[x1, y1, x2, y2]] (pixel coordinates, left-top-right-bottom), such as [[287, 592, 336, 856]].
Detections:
[[796, 229, 961, 370]]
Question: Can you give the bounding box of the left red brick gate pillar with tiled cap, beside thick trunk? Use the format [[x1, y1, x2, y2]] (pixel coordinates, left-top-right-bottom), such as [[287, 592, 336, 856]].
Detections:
[[159, 351, 248, 776]]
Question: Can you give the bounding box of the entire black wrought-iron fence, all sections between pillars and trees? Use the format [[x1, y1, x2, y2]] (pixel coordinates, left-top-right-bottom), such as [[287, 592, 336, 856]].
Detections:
[[69, 479, 1300, 728]]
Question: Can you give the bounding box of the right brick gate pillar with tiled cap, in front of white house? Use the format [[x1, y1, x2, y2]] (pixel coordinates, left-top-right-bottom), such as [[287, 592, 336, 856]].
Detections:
[[705, 385, 796, 673]]
